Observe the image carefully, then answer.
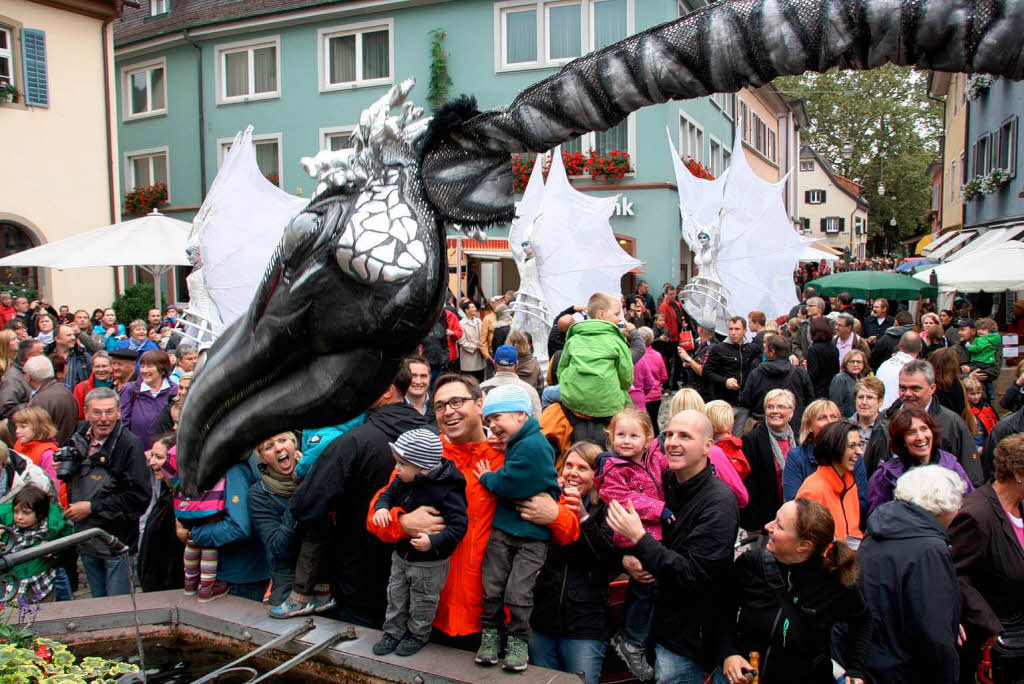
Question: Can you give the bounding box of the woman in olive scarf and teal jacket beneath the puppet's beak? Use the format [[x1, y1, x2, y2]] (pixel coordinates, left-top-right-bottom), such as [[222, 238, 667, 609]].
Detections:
[[249, 432, 302, 606]]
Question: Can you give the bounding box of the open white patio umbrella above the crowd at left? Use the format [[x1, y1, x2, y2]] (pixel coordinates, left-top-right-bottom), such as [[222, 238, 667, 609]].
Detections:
[[0, 209, 191, 308]]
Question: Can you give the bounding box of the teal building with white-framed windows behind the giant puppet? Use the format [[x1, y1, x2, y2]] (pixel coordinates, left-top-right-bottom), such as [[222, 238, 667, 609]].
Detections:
[[116, 0, 799, 298]]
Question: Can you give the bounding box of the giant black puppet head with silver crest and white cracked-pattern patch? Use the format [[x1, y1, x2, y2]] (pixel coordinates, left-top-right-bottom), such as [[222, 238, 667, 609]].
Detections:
[[178, 80, 456, 491]]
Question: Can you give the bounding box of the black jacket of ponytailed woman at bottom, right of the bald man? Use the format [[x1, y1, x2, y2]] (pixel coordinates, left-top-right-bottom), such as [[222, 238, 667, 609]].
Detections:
[[716, 539, 871, 684]]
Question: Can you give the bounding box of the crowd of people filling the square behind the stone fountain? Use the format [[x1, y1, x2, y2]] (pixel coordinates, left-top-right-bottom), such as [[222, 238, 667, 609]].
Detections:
[[0, 283, 1024, 684]]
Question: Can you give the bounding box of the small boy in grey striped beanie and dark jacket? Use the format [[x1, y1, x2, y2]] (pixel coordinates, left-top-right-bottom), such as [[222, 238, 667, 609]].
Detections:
[[373, 428, 469, 655]]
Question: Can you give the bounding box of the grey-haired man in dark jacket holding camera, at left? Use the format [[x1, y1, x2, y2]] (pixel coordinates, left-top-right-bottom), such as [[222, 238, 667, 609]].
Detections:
[[61, 387, 152, 598]]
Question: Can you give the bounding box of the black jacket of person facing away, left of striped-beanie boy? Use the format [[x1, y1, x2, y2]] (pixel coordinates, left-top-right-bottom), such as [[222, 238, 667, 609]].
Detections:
[[291, 403, 428, 626]]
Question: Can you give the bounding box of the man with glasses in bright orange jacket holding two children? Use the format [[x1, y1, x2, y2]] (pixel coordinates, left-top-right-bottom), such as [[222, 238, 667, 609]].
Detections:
[[362, 373, 580, 651]]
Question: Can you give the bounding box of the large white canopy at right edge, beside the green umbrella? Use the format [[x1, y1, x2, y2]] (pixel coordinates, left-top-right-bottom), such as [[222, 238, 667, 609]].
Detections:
[[914, 242, 1024, 293]]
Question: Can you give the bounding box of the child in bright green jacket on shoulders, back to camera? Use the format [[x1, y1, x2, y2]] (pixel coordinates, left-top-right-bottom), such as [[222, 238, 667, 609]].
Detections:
[[558, 292, 633, 418]]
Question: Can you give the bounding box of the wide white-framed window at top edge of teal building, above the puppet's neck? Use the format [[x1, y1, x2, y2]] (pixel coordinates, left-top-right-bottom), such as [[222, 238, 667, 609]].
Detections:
[[495, 0, 635, 71]]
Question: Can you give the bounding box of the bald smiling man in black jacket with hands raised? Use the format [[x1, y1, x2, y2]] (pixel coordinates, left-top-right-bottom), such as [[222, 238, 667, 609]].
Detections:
[[608, 411, 739, 682]]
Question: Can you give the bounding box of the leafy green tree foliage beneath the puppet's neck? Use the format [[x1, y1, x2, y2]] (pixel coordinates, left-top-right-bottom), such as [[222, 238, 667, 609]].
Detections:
[[774, 66, 942, 241]]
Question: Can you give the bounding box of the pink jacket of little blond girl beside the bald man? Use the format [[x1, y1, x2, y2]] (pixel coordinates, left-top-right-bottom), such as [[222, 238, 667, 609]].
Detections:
[[596, 439, 669, 548]]
